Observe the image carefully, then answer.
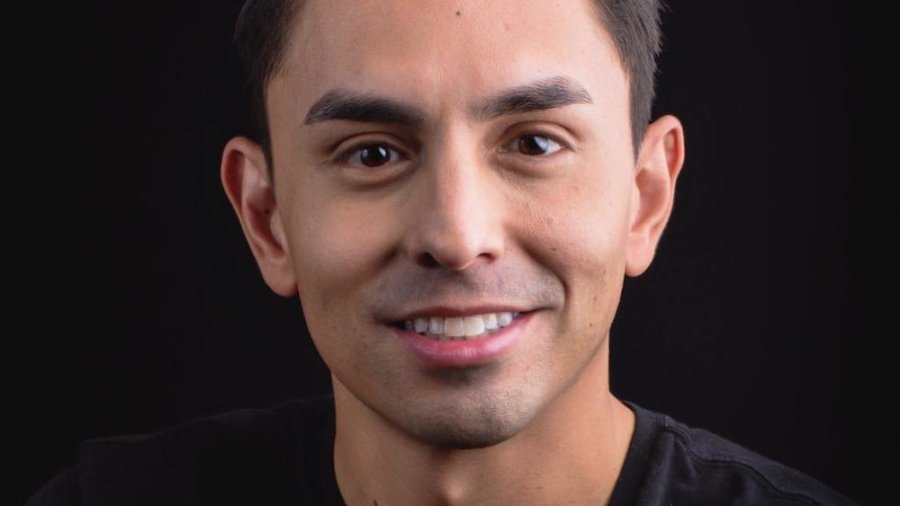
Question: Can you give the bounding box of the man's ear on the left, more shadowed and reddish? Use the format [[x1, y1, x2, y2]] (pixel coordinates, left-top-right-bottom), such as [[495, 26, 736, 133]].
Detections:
[[220, 137, 297, 297]]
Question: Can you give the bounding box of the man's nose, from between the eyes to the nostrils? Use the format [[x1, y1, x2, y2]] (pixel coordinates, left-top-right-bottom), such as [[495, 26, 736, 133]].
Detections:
[[406, 138, 505, 271]]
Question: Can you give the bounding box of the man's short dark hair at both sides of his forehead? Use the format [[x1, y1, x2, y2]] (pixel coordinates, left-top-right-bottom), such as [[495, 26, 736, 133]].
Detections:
[[234, 0, 667, 184]]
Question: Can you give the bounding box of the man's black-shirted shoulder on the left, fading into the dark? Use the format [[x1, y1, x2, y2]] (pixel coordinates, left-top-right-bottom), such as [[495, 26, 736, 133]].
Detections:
[[29, 396, 334, 506]]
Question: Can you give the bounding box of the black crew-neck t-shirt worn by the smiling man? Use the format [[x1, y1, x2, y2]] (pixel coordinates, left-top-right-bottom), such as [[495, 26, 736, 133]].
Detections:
[[27, 396, 855, 506]]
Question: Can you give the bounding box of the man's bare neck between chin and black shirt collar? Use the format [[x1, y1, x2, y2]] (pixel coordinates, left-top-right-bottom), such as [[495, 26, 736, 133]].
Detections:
[[333, 339, 634, 506]]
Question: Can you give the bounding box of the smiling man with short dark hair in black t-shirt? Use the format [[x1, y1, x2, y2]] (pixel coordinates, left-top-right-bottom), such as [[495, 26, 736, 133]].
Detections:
[[32, 0, 850, 505]]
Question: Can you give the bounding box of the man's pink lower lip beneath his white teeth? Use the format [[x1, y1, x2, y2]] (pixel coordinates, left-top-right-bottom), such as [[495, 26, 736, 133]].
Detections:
[[391, 312, 533, 367]]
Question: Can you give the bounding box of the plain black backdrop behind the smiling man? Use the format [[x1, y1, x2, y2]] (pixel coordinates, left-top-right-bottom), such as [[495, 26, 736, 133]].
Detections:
[[17, 0, 868, 503]]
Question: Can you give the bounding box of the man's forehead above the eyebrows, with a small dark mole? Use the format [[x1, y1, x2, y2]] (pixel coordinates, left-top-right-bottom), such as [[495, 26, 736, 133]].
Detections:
[[271, 0, 625, 119]]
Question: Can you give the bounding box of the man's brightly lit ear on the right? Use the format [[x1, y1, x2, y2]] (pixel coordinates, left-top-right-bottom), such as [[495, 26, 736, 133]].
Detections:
[[625, 115, 684, 276]]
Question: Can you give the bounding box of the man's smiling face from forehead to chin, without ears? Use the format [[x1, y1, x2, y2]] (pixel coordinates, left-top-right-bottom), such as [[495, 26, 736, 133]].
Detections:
[[268, 0, 635, 447]]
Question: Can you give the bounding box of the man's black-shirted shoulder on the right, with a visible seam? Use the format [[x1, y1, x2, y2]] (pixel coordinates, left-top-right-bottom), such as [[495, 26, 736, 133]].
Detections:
[[627, 403, 854, 506]]
